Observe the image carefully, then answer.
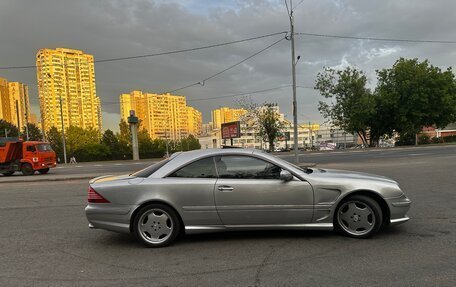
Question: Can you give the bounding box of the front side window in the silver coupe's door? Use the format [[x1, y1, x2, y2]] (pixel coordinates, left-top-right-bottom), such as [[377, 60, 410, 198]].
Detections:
[[215, 156, 281, 179]]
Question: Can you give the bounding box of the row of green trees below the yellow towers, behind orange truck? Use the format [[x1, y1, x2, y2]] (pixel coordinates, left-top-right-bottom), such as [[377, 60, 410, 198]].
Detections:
[[0, 120, 201, 162]]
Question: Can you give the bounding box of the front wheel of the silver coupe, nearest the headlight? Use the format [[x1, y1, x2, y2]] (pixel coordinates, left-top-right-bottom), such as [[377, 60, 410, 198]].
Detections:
[[334, 195, 383, 238]]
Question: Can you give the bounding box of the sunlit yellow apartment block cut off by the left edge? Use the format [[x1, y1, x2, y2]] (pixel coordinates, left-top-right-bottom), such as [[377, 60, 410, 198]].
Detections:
[[0, 78, 30, 130]]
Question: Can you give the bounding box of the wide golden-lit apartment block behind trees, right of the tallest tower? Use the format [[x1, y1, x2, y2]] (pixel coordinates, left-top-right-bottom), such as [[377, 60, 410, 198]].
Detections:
[[120, 91, 202, 140]]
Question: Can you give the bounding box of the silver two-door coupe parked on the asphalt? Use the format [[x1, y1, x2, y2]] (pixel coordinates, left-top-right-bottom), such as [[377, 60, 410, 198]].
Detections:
[[85, 149, 411, 247]]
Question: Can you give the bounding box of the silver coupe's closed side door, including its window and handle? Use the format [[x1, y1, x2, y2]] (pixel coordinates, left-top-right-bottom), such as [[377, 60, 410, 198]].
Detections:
[[214, 155, 313, 225]]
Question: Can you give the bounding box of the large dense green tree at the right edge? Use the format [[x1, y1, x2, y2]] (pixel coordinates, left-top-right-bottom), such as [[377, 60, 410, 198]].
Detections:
[[376, 58, 456, 145]]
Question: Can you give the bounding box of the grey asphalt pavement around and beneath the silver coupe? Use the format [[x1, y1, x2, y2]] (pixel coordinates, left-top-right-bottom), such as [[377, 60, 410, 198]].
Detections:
[[0, 147, 456, 286]]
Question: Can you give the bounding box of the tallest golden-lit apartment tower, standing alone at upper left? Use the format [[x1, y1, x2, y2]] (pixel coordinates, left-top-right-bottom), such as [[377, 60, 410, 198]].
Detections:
[[36, 48, 101, 131]]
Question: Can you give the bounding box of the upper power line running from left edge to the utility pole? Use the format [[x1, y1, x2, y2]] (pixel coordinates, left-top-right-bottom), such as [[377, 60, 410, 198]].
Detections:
[[0, 31, 287, 70]]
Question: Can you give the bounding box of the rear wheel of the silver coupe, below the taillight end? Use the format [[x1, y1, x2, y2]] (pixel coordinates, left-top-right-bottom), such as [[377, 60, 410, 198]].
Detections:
[[133, 203, 181, 247]]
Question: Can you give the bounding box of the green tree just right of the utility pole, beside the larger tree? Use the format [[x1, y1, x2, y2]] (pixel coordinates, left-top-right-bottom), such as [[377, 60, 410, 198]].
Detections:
[[315, 67, 378, 145]]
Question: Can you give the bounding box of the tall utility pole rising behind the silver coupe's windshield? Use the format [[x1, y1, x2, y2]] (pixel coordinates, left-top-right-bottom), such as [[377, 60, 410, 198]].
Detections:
[[285, 0, 300, 164]]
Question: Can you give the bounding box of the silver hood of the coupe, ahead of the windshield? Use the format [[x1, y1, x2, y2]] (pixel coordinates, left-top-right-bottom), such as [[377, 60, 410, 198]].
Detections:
[[310, 168, 398, 185]]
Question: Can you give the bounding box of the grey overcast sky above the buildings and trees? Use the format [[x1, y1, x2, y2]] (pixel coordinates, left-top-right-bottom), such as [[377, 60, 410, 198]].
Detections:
[[0, 0, 456, 130]]
